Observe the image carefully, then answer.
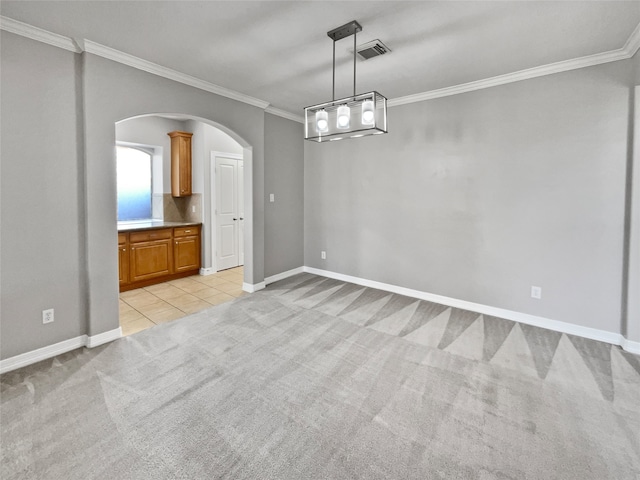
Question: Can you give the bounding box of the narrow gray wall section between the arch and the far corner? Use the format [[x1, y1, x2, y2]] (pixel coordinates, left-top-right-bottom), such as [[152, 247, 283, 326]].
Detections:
[[264, 114, 304, 277]]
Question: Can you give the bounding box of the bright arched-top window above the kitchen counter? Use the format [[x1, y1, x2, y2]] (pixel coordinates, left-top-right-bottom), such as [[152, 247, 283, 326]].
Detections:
[[116, 146, 153, 222]]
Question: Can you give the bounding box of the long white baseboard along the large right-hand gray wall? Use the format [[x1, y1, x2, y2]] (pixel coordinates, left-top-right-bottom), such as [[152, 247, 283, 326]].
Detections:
[[304, 267, 640, 353]]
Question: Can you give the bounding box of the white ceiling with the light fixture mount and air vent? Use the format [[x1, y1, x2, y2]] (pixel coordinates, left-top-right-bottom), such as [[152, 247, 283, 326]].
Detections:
[[0, 0, 640, 115]]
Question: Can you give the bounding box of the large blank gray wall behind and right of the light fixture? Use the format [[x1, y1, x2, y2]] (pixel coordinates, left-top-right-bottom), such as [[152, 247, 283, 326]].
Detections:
[[304, 61, 633, 332]]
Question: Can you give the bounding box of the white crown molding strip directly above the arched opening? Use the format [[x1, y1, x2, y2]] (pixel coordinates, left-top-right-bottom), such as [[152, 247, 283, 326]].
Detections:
[[84, 40, 269, 109]]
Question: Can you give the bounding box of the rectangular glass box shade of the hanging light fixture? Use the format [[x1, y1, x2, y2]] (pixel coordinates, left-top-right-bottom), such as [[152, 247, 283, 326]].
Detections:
[[304, 92, 387, 142]]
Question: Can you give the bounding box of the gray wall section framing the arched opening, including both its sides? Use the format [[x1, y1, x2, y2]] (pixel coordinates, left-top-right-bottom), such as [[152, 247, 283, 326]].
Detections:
[[79, 53, 265, 340]]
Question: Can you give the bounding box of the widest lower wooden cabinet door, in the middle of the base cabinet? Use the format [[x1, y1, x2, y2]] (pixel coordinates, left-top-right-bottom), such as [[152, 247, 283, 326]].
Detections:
[[129, 239, 173, 282]]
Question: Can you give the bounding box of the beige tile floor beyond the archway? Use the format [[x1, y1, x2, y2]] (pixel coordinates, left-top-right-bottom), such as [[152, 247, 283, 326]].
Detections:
[[120, 267, 244, 335]]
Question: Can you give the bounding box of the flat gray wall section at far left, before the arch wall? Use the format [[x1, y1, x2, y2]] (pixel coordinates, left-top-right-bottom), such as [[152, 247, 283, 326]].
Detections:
[[0, 32, 87, 358]]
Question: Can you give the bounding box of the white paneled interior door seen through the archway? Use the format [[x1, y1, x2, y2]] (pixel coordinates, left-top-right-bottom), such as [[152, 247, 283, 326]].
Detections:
[[215, 155, 244, 270]]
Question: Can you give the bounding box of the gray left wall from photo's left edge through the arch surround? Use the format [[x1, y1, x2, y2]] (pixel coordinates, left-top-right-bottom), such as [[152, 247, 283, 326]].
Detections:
[[0, 31, 303, 359]]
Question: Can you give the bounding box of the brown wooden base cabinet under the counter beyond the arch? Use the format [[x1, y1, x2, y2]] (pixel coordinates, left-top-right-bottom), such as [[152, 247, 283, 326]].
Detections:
[[118, 225, 201, 291]]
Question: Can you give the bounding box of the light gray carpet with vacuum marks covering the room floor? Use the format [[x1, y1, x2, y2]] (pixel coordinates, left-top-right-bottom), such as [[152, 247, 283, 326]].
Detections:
[[0, 274, 640, 480]]
